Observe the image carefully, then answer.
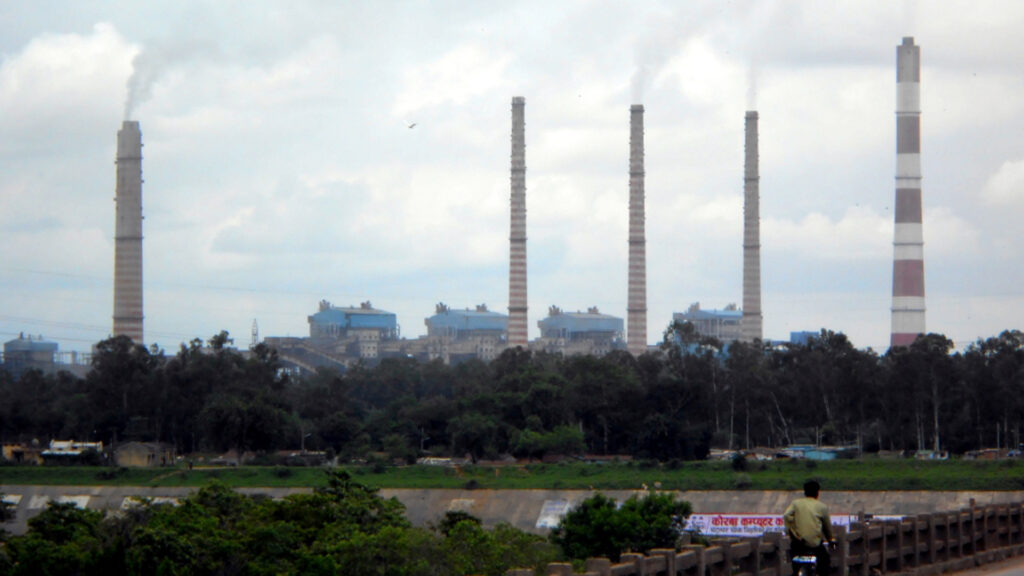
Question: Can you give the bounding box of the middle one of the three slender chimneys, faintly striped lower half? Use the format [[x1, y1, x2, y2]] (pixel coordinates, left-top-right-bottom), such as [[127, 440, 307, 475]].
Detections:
[[626, 105, 647, 356]]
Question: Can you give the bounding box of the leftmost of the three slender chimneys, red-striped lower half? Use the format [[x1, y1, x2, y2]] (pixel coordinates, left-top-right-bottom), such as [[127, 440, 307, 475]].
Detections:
[[508, 96, 528, 347]]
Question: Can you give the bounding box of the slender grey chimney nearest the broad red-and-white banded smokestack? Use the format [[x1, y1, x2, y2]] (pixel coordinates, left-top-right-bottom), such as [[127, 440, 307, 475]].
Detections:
[[739, 111, 763, 342]]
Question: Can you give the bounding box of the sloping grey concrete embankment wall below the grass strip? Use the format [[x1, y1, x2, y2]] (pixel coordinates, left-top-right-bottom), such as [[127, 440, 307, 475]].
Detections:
[[0, 485, 1024, 534]]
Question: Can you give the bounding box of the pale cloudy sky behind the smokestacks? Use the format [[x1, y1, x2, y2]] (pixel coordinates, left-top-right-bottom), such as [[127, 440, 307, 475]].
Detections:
[[0, 0, 1024, 352]]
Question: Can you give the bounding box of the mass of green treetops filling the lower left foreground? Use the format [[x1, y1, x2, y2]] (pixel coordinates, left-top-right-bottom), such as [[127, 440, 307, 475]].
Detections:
[[0, 472, 557, 576]]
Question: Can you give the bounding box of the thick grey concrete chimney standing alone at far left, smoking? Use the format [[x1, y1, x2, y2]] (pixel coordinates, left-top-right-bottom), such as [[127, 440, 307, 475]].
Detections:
[[114, 120, 142, 344]]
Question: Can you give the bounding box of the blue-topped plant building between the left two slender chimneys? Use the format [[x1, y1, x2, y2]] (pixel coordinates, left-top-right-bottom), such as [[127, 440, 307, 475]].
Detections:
[[532, 306, 626, 356]]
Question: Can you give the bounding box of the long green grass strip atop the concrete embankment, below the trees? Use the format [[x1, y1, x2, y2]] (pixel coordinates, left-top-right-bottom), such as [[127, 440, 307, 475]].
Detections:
[[0, 458, 1024, 492]]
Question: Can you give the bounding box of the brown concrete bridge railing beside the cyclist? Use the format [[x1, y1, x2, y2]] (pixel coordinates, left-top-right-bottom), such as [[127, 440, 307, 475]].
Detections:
[[507, 502, 1024, 576]]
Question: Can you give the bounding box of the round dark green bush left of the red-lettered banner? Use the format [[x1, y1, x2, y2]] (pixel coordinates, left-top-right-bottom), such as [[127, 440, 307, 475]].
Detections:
[[551, 493, 693, 562]]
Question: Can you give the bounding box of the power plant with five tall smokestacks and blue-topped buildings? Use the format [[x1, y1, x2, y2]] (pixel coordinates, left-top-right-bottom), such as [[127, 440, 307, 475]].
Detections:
[[90, 37, 925, 366]]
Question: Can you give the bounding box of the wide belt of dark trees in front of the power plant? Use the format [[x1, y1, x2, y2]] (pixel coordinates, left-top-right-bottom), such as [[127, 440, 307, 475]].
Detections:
[[0, 324, 1024, 461]]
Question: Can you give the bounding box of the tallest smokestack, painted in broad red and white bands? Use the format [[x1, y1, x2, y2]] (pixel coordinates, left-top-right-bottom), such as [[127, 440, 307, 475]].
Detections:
[[890, 37, 925, 346]]
